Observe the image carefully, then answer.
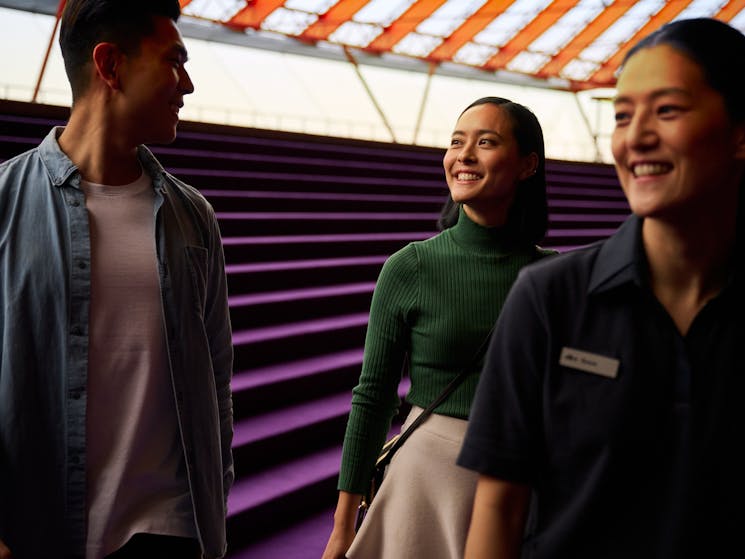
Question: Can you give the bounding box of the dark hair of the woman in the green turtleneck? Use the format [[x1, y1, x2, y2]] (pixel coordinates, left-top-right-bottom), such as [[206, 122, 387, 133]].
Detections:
[[437, 97, 548, 244]]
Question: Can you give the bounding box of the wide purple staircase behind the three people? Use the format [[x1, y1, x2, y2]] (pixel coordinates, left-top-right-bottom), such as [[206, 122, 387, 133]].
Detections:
[[0, 101, 629, 559]]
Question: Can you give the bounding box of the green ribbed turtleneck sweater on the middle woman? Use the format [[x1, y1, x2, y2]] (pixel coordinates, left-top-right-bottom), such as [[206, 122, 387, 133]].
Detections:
[[339, 210, 551, 493]]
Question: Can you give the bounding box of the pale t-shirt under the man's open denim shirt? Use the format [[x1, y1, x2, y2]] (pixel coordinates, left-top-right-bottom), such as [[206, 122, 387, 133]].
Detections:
[[81, 172, 196, 559]]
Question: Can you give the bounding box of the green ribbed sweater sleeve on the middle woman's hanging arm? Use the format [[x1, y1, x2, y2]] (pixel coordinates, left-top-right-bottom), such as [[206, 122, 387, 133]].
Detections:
[[339, 245, 417, 493]]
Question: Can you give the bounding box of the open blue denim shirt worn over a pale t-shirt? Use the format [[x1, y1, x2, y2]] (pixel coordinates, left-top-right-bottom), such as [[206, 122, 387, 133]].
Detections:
[[0, 128, 234, 559]]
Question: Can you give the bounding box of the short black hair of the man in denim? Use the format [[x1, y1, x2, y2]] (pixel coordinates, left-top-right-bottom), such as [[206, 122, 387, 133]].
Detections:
[[59, 0, 181, 100]]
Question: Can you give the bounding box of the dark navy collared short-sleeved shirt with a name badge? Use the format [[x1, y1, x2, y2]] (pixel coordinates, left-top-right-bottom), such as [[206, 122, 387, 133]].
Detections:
[[459, 216, 745, 559]]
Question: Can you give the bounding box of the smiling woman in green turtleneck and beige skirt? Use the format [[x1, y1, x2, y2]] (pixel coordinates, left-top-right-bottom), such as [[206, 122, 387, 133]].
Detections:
[[323, 97, 550, 559]]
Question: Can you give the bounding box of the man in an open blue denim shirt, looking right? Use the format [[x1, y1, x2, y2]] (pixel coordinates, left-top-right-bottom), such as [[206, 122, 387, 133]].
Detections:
[[0, 0, 233, 559]]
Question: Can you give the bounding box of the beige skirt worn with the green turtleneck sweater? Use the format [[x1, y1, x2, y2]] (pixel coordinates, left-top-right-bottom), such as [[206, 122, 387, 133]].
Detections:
[[347, 406, 478, 559]]
